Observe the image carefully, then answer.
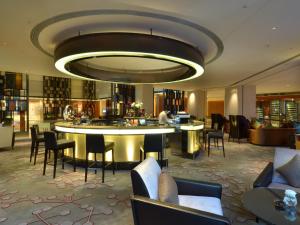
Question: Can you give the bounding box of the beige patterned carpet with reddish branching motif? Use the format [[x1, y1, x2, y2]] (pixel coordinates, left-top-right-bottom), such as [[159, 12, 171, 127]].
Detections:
[[0, 135, 273, 225]]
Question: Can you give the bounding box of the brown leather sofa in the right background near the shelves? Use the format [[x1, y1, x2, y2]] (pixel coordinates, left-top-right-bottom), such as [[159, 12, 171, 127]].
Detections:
[[249, 128, 296, 146]]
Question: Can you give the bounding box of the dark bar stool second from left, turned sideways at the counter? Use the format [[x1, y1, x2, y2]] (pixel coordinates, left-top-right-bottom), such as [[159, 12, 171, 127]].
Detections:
[[43, 131, 76, 178]]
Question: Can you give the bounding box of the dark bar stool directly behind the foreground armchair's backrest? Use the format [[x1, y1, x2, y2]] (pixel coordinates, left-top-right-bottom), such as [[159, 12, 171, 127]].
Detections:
[[140, 134, 164, 168]]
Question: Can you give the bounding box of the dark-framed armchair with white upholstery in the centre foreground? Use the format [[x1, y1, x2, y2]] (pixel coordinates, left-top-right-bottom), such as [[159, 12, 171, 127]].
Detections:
[[131, 157, 230, 225]]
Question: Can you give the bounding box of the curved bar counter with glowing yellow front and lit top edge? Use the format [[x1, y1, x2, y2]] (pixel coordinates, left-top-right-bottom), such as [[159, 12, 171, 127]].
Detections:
[[55, 122, 175, 166]]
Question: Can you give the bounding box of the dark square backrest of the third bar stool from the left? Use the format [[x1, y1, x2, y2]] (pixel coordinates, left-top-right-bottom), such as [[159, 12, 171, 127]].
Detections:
[[85, 134, 105, 153]]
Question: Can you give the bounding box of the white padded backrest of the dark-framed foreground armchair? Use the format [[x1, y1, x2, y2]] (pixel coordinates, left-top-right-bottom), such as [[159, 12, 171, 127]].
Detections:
[[134, 157, 161, 200]]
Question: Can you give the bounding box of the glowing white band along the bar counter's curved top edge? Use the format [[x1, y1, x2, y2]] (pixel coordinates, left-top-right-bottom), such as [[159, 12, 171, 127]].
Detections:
[[55, 125, 175, 135]]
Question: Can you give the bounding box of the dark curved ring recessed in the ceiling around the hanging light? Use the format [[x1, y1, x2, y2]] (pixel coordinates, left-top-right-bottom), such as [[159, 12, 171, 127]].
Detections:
[[30, 9, 224, 64]]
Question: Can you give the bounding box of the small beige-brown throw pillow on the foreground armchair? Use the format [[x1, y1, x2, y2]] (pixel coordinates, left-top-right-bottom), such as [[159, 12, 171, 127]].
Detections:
[[158, 172, 179, 204]]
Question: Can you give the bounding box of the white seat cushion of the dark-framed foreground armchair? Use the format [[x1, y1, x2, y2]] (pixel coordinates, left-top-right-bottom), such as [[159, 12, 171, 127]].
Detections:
[[178, 195, 223, 216]]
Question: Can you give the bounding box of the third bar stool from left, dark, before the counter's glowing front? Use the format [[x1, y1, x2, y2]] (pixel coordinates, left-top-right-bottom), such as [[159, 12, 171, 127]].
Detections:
[[85, 134, 116, 183]]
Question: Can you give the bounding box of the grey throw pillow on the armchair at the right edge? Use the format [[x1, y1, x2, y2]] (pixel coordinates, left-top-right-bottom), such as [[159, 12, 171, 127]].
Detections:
[[277, 154, 300, 188]]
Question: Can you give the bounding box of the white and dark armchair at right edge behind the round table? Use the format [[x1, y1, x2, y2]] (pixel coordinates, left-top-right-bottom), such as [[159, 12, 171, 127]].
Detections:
[[253, 147, 300, 193]]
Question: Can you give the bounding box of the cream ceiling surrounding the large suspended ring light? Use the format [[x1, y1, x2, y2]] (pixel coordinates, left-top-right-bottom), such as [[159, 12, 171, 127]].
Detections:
[[0, 0, 300, 98]]
